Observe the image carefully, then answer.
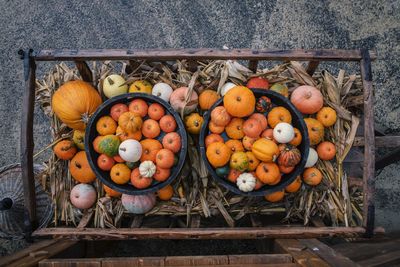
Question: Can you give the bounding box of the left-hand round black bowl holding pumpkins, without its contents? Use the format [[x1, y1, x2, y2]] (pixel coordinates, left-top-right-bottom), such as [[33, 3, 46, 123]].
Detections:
[[85, 93, 187, 195]]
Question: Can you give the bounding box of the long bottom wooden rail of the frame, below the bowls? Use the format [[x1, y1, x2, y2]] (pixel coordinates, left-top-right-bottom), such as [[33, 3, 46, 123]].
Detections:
[[33, 226, 384, 240]]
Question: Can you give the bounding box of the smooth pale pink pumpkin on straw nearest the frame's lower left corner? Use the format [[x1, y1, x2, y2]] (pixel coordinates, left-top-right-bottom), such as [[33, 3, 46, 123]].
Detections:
[[69, 184, 97, 209]]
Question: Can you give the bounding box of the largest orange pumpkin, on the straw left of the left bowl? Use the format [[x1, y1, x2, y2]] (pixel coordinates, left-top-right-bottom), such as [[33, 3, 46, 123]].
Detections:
[[51, 80, 102, 130]]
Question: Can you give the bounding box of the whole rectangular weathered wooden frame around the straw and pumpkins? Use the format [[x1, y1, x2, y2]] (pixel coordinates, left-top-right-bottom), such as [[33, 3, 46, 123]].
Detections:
[[20, 49, 388, 239]]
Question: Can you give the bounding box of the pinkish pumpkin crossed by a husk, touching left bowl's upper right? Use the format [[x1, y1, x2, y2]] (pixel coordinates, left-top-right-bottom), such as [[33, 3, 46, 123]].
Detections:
[[169, 87, 199, 114]]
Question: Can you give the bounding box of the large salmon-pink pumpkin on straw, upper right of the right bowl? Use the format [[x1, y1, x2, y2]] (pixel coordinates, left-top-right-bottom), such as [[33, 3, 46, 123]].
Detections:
[[290, 85, 324, 114]]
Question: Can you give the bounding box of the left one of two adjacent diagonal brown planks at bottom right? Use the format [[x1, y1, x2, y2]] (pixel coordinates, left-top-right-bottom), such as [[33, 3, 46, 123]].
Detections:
[[274, 239, 329, 267]]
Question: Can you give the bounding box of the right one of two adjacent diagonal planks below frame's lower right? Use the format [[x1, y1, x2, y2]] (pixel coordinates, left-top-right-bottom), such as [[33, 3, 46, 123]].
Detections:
[[299, 239, 359, 267]]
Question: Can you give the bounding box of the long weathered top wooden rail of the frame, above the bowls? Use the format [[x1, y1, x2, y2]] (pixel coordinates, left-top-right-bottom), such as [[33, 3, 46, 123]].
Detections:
[[34, 48, 376, 61]]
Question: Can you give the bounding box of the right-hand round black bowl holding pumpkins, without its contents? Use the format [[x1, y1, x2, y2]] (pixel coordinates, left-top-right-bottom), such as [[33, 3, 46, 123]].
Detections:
[[199, 89, 310, 196]]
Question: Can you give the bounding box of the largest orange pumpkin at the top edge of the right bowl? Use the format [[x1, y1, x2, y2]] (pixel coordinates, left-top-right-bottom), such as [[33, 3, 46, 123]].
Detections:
[[224, 86, 256, 118]]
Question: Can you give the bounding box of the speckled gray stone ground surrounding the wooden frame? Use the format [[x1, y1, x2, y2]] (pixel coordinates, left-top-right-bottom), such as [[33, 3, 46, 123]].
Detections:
[[0, 0, 400, 231]]
